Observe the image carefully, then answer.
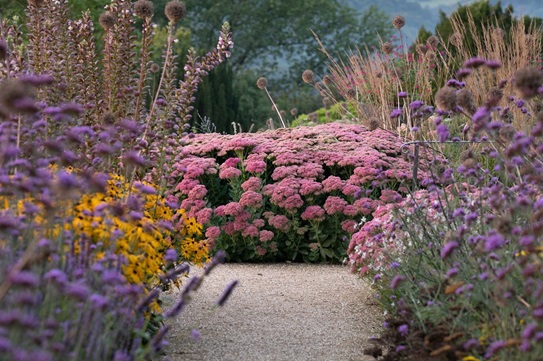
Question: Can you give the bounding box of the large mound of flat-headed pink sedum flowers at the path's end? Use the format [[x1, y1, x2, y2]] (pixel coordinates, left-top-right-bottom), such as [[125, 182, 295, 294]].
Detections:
[[171, 123, 427, 262]]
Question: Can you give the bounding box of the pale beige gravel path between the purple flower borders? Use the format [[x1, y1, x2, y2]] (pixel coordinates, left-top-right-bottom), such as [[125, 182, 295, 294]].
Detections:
[[163, 263, 382, 361]]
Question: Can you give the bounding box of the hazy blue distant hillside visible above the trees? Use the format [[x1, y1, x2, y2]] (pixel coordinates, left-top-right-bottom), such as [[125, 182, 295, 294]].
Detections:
[[346, 0, 543, 42]]
